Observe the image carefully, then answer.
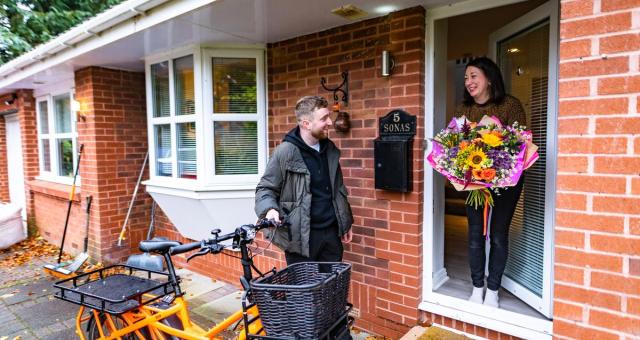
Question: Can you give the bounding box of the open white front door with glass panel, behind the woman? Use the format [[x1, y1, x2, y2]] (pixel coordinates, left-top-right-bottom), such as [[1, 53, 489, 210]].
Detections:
[[489, 3, 557, 318]]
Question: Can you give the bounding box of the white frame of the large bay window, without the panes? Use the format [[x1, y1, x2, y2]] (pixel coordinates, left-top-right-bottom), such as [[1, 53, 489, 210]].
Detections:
[[145, 46, 267, 196]]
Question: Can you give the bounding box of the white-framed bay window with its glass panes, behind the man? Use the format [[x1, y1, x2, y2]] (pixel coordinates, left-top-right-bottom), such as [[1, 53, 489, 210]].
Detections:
[[146, 48, 267, 191]]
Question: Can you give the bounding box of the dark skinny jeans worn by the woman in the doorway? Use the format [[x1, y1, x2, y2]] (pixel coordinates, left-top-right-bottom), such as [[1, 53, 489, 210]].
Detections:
[[466, 176, 524, 290]]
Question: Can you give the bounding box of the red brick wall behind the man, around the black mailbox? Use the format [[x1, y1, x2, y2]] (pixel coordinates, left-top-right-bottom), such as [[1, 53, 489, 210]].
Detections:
[[268, 7, 425, 338]]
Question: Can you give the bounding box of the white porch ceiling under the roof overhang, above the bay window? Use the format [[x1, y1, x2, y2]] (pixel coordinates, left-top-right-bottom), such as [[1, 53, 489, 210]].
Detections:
[[10, 0, 461, 88]]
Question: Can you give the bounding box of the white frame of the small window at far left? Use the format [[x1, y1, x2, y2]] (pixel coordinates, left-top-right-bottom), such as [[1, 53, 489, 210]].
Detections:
[[36, 89, 80, 186]]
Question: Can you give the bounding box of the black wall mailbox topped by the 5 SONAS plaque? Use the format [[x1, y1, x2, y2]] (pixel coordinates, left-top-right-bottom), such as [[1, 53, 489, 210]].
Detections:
[[373, 110, 416, 192]]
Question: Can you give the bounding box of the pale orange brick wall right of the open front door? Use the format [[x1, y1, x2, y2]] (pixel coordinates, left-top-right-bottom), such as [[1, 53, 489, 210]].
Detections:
[[553, 0, 640, 339]]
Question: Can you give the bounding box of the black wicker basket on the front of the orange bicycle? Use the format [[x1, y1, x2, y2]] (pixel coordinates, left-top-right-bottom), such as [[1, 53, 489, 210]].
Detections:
[[251, 262, 351, 339]]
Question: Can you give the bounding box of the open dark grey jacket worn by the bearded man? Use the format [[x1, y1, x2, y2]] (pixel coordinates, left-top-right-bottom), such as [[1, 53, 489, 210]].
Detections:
[[255, 141, 353, 256]]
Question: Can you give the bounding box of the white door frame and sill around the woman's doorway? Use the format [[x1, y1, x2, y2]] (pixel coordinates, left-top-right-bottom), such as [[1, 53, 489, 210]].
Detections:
[[418, 0, 559, 339]]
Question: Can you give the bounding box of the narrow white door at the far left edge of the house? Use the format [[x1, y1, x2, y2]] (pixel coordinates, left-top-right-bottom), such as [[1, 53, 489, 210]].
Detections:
[[4, 114, 27, 220]]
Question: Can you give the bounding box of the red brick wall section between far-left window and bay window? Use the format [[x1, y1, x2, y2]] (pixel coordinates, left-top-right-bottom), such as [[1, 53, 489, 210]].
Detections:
[[75, 67, 151, 263]]
